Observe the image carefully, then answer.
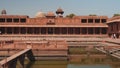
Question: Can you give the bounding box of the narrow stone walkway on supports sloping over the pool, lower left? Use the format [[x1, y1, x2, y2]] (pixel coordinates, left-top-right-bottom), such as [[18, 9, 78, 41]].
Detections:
[[0, 48, 35, 68]]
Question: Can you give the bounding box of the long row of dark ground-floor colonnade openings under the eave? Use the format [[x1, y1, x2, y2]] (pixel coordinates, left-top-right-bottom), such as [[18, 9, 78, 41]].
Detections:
[[0, 27, 107, 35]]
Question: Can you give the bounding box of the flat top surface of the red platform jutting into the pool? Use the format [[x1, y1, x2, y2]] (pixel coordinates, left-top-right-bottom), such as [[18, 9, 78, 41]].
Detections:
[[0, 40, 68, 50]]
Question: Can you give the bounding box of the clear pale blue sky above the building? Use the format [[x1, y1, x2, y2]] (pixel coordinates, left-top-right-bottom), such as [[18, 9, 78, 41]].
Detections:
[[0, 0, 120, 17]]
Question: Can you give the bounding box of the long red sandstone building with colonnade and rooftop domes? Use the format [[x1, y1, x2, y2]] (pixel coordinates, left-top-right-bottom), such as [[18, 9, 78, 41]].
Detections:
[[0, 8, 120, 37]]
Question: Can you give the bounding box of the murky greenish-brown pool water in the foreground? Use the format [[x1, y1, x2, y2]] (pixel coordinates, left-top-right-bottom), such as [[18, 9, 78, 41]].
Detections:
[[17, 55, 120, 68]]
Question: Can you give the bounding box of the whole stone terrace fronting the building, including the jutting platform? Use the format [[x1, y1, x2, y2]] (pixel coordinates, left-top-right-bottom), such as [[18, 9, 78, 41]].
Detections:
[[0, 37, 120, 59]]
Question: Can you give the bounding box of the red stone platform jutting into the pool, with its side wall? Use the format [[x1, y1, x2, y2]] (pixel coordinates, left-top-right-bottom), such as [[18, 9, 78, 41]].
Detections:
[[0, 40, 68, 60]]
